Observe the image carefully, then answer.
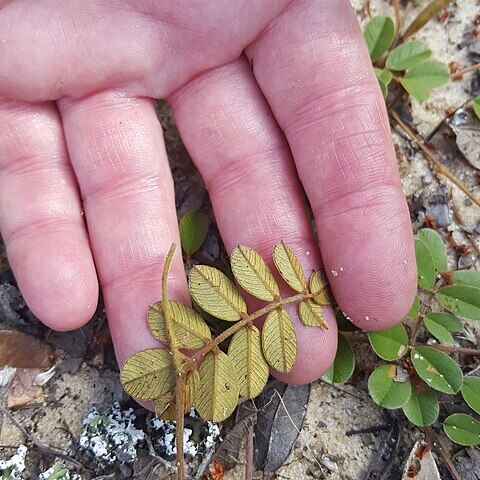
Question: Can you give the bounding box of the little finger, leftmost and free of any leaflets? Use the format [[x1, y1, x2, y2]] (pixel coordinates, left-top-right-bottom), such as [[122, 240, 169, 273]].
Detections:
[[0, 99, 98, 330]]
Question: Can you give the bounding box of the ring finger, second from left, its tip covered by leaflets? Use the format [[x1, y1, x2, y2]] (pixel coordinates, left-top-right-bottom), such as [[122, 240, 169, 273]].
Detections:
[[60, 92, 189, 365]]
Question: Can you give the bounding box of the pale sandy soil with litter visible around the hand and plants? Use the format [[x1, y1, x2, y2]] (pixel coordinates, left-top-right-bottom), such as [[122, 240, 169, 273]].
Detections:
[[0, 0, 480, 480]]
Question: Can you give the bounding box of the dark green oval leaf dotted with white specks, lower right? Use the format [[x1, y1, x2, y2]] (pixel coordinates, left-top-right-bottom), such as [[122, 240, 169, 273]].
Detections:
[[410, 347, 463, 394]]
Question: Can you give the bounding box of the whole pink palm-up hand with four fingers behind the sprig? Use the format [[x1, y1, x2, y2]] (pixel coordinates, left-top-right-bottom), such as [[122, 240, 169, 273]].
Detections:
[[0, 0, 416, 402]]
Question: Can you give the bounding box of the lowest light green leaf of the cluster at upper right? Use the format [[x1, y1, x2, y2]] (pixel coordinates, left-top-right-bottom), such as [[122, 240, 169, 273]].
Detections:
[[400, 60, 450, 102]]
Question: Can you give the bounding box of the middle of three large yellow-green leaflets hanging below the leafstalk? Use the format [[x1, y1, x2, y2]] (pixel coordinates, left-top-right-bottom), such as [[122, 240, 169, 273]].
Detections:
[[228, 326, 268, 398]]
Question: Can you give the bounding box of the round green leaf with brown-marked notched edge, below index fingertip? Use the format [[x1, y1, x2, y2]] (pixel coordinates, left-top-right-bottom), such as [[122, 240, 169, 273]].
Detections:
[[368, 365, 412, 409]]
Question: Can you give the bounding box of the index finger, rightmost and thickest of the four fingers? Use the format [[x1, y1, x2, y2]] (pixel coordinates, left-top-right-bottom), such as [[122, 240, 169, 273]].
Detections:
[[247, 0, 416, 330]]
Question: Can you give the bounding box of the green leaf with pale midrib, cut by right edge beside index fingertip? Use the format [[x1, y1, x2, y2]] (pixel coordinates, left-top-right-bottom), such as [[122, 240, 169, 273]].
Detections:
[[435, 285, 480, 320]]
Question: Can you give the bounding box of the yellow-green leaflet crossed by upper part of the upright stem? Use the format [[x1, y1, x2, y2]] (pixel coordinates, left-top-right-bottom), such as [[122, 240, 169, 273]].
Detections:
[[148, 300, 211, 349]]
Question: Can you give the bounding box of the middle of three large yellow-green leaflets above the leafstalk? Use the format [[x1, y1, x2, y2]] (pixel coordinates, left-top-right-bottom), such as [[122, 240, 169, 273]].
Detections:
[[230, 245, 280, 302]]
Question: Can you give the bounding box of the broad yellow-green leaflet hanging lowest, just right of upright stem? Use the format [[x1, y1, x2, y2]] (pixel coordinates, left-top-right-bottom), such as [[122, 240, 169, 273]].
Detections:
[[195, 351, 239, 422]]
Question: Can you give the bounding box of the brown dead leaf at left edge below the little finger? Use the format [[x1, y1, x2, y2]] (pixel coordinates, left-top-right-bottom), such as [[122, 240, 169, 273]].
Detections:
[[0, 330, 53, 368]]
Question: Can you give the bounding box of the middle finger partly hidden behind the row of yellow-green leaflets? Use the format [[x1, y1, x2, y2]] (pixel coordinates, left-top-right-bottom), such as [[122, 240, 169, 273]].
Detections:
[[169, 58, 337, 383]]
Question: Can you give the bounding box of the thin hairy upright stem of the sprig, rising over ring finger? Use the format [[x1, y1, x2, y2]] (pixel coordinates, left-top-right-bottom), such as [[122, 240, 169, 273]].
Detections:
[[162, 243, 185, 480]]
